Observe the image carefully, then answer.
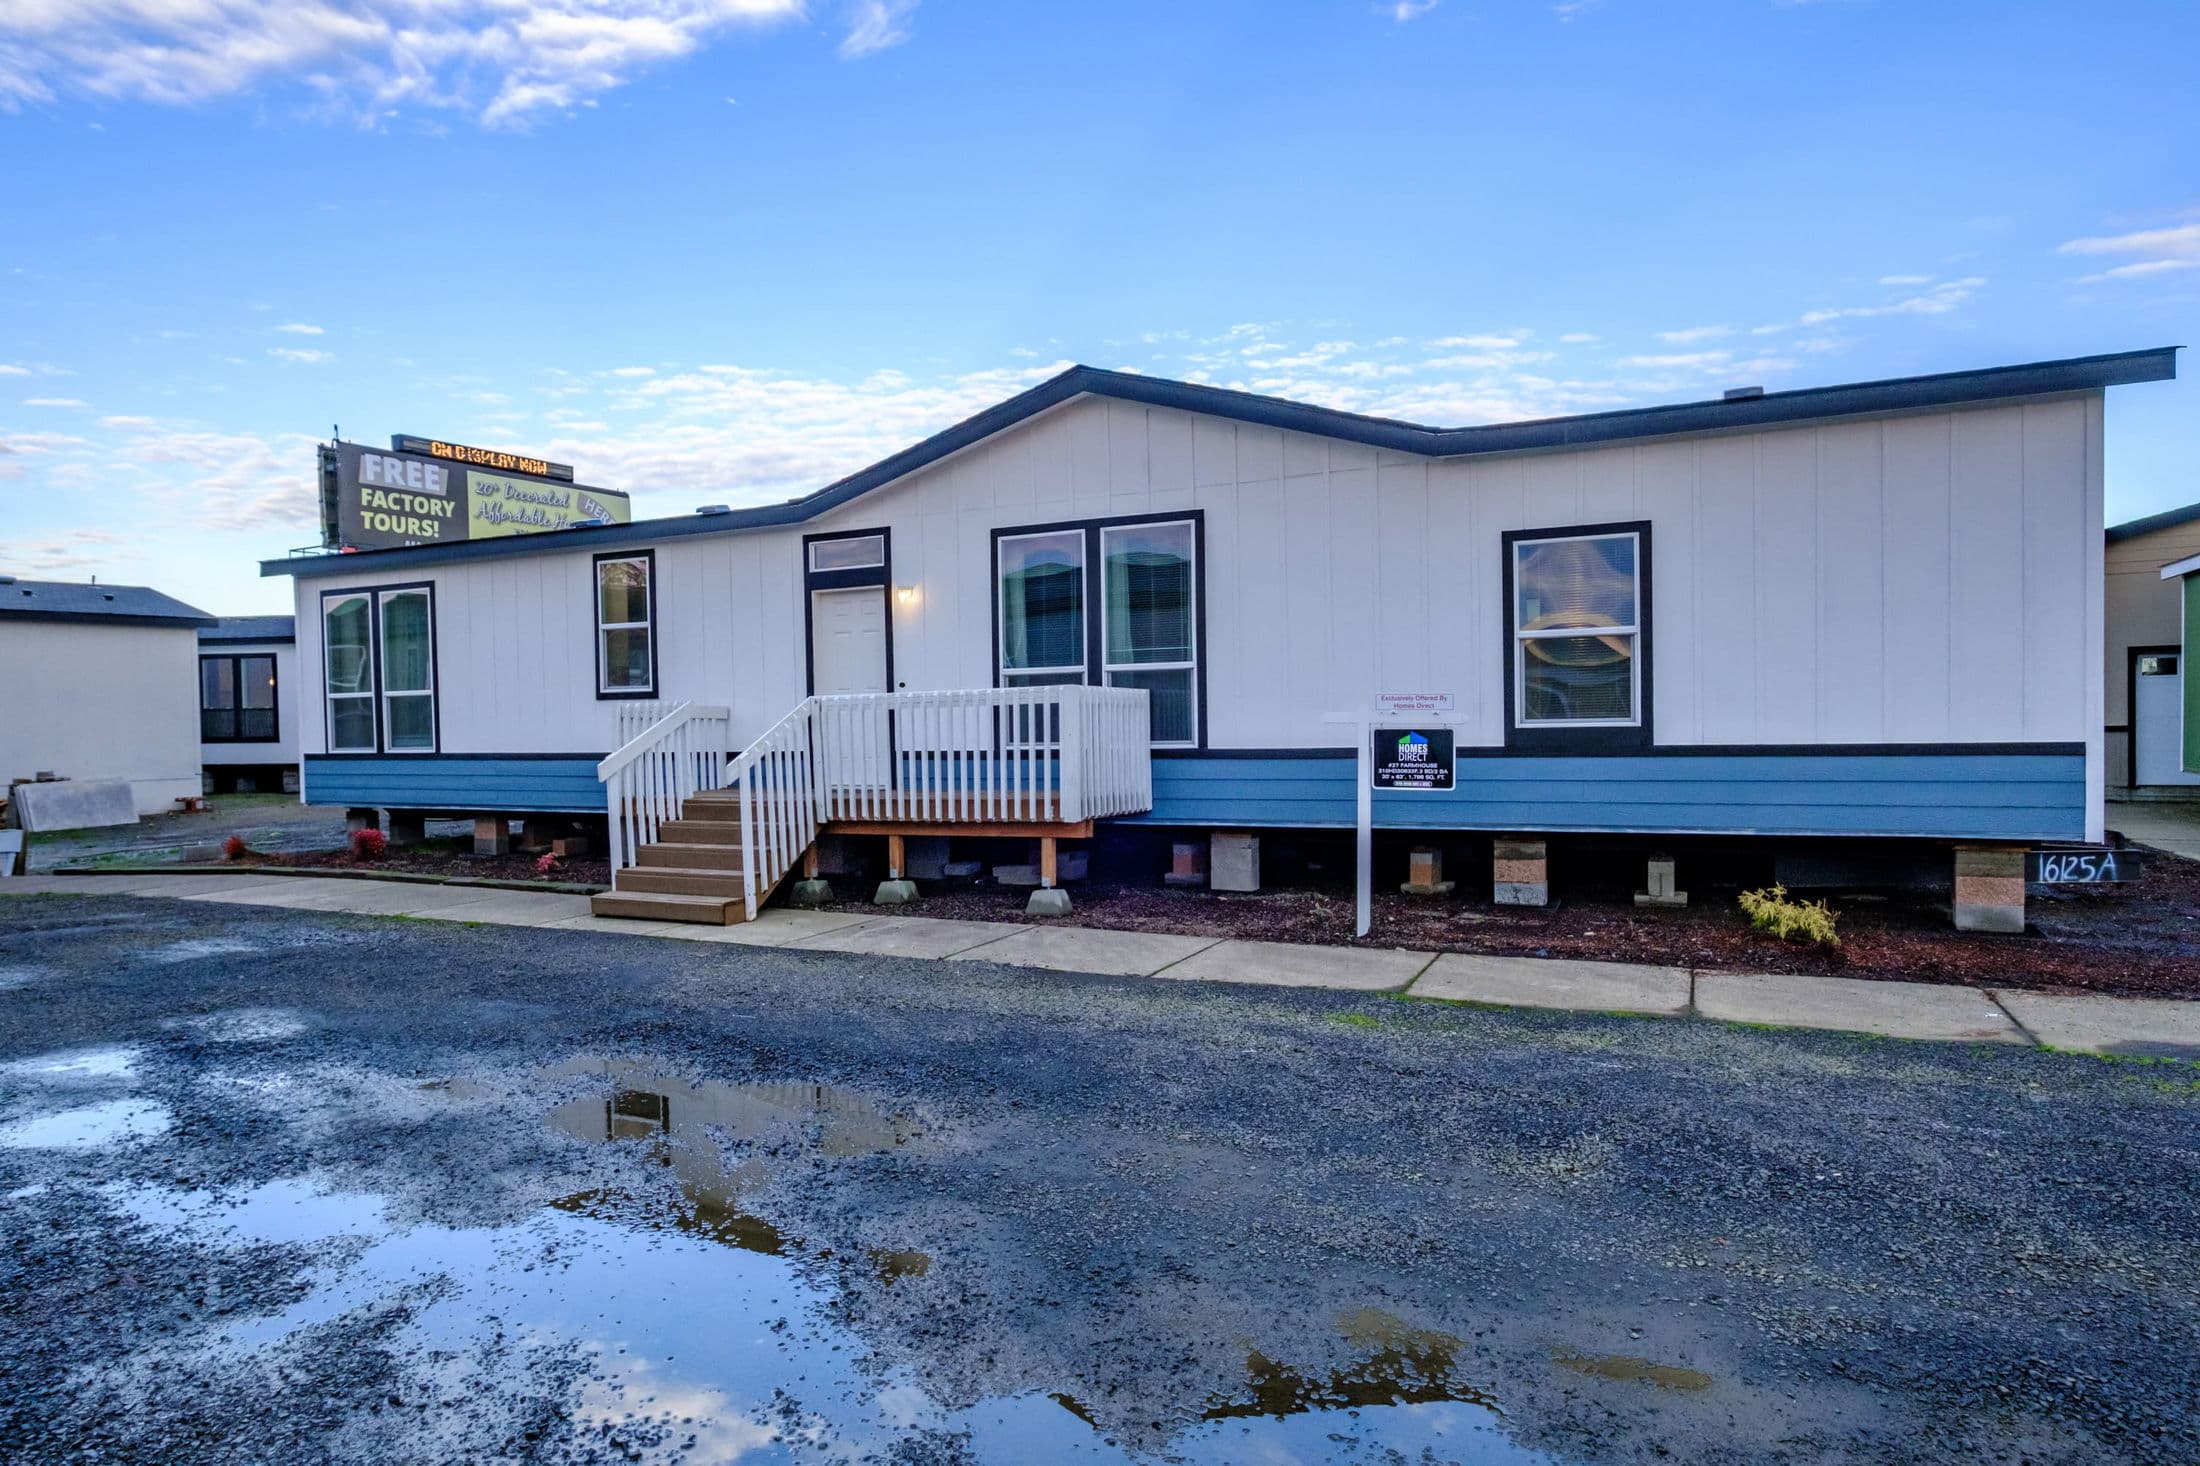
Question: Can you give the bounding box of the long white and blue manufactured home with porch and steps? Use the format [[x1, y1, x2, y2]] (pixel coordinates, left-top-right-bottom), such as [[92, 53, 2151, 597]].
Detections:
[[262, 348, 2176, 927]]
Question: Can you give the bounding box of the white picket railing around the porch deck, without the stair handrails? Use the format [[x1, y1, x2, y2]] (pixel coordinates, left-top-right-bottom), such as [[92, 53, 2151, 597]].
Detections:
[[814, 687, 1153, 823]]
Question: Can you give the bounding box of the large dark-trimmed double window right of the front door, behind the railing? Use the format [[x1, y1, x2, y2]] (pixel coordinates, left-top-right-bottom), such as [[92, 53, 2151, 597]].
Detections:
[[994, 515, 1201, 746]]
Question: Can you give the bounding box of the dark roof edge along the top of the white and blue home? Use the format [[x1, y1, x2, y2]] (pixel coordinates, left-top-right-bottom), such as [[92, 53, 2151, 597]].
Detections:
[[260, 346, 2180, 579]]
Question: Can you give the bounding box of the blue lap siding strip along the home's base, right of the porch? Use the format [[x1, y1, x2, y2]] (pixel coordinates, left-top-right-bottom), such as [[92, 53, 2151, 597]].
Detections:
[[1137, 746, 2086, 841]]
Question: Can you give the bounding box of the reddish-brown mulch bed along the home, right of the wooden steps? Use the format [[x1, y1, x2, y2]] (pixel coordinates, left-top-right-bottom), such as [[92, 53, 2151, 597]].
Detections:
[[809, 852, 2200, 997]]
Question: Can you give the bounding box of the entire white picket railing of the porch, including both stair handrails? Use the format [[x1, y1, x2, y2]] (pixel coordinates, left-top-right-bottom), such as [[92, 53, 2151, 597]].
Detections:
[[596, 687, 1153, 918]]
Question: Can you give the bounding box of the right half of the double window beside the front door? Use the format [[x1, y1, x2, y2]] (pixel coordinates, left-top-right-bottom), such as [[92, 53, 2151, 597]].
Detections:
[[1100, 519, 1199, 744]]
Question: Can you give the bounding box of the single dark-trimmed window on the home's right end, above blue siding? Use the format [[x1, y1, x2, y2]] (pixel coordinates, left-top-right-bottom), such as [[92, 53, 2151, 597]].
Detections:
[[1505, 526, 1648, 731]]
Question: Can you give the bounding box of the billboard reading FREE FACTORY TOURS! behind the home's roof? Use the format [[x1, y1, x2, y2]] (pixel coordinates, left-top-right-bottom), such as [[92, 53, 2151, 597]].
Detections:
[[323, 442, 634, 550]]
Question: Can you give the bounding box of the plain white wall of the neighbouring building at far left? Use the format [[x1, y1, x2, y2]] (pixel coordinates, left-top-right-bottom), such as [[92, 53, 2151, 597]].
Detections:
[[0, 621, 200, 814]]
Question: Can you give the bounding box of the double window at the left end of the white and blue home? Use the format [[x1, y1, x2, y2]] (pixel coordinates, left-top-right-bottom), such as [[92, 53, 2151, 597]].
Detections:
[[321, 586, 436, 753]]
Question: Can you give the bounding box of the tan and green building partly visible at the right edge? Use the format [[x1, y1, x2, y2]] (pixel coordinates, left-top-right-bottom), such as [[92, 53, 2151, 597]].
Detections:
[[2103, 504, 2200, 799]]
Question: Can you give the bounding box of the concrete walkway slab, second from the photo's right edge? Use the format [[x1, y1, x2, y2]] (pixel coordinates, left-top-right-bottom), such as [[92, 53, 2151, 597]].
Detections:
[[1696, 973, 2026, 1043]]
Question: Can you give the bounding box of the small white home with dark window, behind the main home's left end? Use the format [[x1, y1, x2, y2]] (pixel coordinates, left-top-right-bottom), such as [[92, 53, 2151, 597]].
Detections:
[[198, 616, 297, 795]]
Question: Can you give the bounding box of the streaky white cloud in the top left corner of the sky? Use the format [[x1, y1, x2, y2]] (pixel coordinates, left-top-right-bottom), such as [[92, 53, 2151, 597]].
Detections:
[[0, 0, 849, 125]]
